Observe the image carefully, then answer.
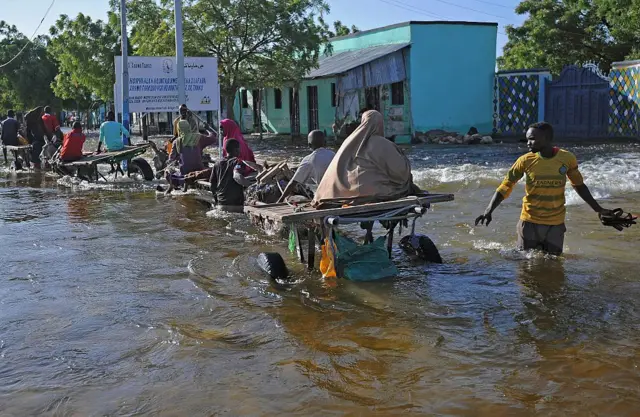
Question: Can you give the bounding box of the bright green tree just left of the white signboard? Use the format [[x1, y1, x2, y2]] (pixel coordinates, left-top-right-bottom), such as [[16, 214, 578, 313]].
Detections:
[[49, 13, 120, 101]]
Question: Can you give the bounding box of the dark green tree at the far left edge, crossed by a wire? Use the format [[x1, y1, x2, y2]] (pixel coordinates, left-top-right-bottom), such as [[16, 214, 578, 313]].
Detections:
[[0, 21, 60, 110]]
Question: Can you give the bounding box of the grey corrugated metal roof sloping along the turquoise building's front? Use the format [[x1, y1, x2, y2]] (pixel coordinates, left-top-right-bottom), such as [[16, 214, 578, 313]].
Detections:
[[305, 43, 411, 78]]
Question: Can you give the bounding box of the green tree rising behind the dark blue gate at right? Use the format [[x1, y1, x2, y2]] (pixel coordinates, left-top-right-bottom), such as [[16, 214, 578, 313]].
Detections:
[[498, 0, 640, 73]]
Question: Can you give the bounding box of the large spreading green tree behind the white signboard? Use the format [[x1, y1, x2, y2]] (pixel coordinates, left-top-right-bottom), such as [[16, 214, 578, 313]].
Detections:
[[128, 0, 329, 118]]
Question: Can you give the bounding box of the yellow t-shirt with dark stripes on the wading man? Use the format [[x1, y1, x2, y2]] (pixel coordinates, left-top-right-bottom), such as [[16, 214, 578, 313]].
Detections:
[[498, 149, 584, 226]]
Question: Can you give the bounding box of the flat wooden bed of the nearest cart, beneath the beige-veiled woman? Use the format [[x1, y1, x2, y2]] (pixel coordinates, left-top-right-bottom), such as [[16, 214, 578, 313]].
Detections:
[[244, 194, 454, 223]]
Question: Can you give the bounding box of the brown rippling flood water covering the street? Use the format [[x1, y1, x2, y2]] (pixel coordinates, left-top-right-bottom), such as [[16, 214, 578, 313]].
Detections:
[[0, 138, 640, 416]]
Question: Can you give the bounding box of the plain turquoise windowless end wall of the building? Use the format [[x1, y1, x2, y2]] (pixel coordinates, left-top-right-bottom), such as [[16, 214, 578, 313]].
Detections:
[[409, 24, 497, 133]]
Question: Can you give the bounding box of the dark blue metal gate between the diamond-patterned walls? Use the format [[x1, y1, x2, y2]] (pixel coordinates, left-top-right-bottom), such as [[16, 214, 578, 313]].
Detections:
[[545, 64, 610, 138]]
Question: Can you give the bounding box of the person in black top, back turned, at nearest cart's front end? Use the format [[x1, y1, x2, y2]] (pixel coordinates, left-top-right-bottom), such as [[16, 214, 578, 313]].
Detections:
[[210, 139, 250, 213]]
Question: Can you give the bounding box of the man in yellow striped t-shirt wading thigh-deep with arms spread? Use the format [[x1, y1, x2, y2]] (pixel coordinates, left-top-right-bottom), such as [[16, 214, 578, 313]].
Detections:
[[476, 122, 611, 255]]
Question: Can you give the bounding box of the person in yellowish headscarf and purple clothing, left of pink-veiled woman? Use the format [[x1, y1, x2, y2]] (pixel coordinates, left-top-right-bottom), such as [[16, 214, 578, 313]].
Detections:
[[165, 116, 218, 193]]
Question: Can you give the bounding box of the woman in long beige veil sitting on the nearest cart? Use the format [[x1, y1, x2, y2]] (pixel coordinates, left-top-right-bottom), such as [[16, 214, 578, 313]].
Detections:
[[313, 110, 419, 208]]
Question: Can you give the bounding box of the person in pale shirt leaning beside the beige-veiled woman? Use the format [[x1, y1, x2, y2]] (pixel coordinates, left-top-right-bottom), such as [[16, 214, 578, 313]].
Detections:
[[278, 130, 336, 203]]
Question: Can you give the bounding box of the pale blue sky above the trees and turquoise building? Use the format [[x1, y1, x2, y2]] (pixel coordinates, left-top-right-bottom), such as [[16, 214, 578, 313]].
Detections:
[[0, 0, 524, 55]]
